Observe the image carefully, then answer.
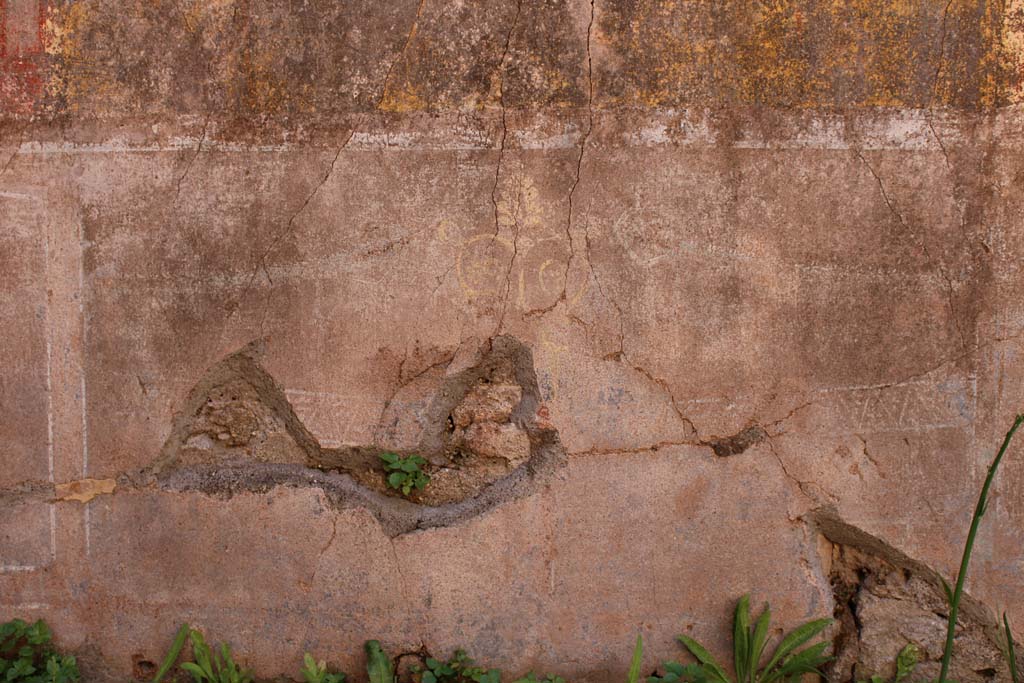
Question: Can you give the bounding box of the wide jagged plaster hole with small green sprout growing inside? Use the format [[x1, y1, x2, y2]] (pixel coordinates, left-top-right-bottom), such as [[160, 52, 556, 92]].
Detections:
[[140, 336, 564, 536]]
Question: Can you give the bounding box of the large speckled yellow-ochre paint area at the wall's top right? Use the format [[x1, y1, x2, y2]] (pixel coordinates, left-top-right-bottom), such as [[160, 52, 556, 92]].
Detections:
[[602, 0, 1022, 108]]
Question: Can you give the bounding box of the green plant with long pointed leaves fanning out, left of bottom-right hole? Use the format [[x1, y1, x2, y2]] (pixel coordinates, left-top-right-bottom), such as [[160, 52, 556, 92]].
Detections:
[[667, 595, 833, 683]]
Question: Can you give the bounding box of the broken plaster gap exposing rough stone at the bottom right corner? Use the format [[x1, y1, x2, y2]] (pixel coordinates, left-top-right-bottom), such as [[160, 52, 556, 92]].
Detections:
[[812, 510, 1024, 683]]
